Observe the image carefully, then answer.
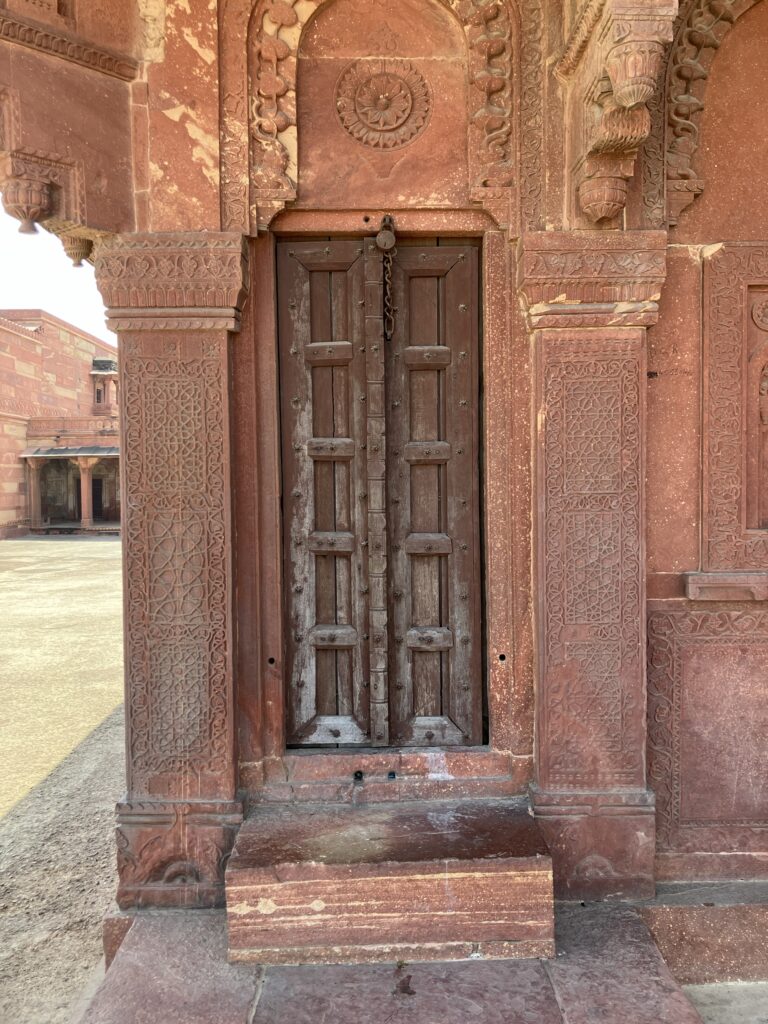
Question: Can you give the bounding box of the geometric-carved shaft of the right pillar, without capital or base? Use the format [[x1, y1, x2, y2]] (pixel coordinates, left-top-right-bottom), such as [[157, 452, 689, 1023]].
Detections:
[[538, 331, 644, 790]]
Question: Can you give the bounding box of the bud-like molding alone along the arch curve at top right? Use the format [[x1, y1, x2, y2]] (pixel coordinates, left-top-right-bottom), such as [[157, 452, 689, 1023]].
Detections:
[[654, 0, 761, 224]]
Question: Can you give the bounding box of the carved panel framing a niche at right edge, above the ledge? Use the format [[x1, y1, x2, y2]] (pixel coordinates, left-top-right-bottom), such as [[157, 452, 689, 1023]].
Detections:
[[702, 244, 768, 570]]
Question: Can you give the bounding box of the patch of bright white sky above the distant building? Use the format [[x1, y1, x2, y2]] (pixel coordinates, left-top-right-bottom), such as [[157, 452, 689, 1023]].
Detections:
[[0, 206, 117, 345]]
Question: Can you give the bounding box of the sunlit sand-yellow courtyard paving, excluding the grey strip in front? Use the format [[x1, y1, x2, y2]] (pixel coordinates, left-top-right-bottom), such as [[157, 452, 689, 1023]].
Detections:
[[0, 537, 123, 818]]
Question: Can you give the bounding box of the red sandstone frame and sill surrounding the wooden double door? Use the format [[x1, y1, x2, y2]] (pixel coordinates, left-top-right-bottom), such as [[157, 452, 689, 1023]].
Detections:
[[231, 210, 534, 799]]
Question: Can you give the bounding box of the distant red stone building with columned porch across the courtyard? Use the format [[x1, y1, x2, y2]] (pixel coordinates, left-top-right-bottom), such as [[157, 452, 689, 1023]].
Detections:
[[0, 309, 120, 539]]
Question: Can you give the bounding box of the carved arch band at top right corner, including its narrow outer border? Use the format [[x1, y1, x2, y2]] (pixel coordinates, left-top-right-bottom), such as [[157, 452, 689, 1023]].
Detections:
[[644, 0, 761, 226]]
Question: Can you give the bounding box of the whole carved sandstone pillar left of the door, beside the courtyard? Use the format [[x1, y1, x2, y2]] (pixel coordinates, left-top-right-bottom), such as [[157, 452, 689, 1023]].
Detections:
[[96, 232, 247, 907]]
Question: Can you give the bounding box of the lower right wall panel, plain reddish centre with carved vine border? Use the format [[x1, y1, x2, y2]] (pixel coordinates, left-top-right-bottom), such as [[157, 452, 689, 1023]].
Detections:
[[648, 606, 768, 853]]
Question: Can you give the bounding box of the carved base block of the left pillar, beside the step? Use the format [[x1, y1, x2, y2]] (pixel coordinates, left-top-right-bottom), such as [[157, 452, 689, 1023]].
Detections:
[[117, 801, 243, 910]]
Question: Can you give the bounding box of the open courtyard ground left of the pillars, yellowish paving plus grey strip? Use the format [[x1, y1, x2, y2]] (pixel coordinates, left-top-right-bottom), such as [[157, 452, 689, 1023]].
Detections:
[[0, 537, 124, 1024]]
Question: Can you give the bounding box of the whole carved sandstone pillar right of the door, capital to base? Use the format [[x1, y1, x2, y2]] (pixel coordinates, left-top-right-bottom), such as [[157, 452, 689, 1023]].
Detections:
[[519, 232, 665, 898]]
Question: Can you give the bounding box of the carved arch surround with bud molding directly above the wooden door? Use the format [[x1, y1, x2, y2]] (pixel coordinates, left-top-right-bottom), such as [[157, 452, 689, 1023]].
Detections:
[[219, 0, 543, 233]]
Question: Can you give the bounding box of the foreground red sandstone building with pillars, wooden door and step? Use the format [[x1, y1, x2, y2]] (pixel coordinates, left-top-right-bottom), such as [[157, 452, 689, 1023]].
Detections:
[[0, 0, 768, 1022]]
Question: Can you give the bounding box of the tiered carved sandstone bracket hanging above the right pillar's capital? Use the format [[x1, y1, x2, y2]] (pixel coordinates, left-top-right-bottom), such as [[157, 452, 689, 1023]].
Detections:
[[555, 0, 677, 223]]
